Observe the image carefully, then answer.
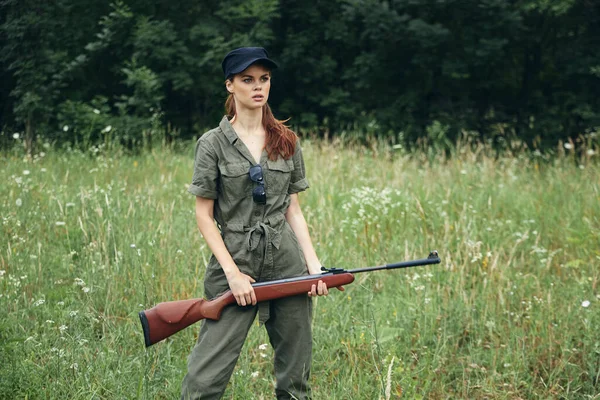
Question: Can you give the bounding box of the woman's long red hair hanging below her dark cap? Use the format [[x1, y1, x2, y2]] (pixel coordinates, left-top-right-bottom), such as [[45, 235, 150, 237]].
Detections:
[[225, 94, 296, 160]]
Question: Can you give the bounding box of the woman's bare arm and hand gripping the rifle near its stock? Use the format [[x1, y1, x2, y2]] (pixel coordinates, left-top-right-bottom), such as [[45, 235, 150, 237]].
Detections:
[[196, 196, 256, 306]]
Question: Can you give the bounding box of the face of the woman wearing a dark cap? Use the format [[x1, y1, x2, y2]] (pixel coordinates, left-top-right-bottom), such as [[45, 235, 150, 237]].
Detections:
[[225, 64, 271, 110]]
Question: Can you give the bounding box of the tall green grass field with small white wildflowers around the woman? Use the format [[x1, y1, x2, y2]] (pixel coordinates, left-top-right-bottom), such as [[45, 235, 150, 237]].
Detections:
[[0, 139, 600, 399]]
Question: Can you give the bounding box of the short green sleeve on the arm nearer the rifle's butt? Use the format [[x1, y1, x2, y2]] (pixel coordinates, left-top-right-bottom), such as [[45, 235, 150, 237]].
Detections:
[[188, 138, 219, 199]]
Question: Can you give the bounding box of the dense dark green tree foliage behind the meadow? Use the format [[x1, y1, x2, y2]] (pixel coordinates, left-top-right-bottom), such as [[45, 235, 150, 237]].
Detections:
[[0, 0, 600, 146]]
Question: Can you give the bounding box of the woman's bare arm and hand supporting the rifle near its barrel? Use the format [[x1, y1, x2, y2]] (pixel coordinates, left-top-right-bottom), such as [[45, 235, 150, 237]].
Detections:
[[285, 193, 329, 296]]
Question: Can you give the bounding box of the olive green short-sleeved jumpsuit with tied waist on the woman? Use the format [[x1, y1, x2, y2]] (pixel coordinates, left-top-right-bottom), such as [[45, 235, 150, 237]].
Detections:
[[182, 117, 312, 400]]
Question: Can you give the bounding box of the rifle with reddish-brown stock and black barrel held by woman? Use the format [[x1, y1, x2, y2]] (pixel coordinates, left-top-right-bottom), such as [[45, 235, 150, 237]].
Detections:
[[139, 251, 441, 347]]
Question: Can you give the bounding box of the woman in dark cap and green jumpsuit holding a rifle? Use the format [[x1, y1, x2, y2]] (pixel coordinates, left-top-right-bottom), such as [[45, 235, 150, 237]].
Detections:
[[182, 47, 328, 400]]
